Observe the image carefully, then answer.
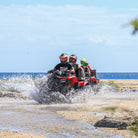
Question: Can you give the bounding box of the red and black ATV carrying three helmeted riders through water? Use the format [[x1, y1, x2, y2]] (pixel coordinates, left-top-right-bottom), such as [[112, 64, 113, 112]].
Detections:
[[48, 71, 98, 96]]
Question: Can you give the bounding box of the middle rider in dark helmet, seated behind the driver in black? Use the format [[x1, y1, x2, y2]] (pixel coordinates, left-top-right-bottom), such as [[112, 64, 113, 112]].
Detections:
[[69, 54, 85, 80]]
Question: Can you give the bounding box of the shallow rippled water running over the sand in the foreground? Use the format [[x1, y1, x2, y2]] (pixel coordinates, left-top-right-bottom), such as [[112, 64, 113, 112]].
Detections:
[[0, 89, 138, 138]]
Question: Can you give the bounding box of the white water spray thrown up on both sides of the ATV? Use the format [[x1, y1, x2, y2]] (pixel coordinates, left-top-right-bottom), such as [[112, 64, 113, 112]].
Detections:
[[0, 75, 136, 104]]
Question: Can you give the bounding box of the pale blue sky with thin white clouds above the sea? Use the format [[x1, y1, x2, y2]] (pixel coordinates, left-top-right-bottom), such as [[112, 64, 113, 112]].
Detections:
[[0, 0, 138, 72]]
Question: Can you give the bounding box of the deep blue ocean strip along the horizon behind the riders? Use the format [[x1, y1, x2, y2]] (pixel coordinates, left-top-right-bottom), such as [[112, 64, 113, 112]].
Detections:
[[0, 72, 138, 79]]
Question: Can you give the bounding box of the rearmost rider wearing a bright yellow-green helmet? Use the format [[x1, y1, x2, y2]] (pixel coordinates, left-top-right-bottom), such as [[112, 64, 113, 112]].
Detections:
[[81, 58, 91, 76]]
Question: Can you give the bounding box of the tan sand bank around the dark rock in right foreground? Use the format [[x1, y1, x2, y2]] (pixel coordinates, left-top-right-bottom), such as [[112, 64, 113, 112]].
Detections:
[[57, 100, 138, 138]]
